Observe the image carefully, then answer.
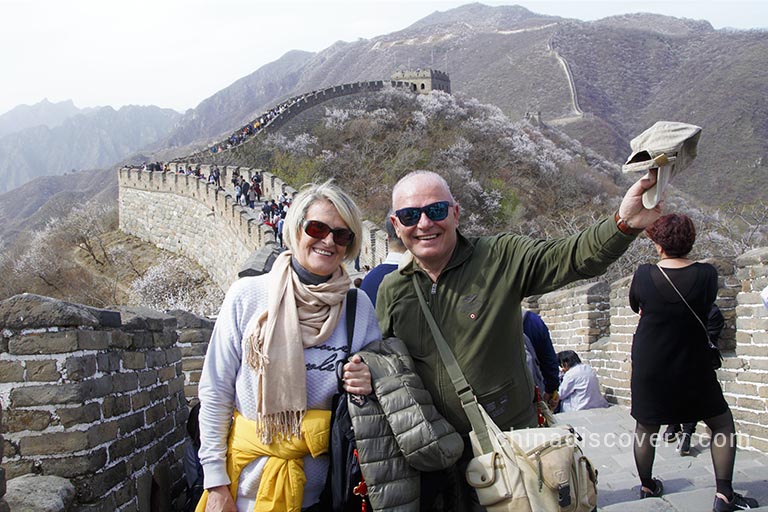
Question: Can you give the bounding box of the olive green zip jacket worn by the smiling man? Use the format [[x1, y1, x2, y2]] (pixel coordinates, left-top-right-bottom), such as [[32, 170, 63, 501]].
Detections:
[[376, 218, 635, 434]]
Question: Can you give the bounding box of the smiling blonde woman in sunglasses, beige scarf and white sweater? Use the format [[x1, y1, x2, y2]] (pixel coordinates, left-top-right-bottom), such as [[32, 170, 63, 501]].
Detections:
[[197, 183, 381, 512]]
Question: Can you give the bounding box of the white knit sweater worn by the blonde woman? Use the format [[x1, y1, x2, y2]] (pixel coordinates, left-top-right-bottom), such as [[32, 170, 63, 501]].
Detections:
[[198, 275, 381, 510]]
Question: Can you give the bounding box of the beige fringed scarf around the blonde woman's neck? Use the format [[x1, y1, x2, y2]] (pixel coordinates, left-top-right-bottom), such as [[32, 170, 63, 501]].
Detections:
[[245, 251, 350, 443]]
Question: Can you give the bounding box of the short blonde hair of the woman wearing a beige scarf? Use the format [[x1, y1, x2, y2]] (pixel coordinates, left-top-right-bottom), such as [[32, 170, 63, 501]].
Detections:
[[283, 180, 363, 261]]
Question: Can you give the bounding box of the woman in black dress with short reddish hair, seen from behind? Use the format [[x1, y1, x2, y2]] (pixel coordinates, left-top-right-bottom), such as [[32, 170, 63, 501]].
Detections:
[[629, 213, 757, 512]]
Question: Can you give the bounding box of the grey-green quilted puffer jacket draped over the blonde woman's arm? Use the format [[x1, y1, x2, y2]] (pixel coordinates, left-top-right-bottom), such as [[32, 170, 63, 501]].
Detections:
[[348, 338, 464, 512]]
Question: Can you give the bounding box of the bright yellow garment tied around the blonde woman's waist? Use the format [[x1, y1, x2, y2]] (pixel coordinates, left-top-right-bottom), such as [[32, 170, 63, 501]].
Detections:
[[195, 409, 331, 512]]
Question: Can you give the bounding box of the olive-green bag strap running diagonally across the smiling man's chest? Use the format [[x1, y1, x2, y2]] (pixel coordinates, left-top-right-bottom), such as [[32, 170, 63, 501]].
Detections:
[[412, 273, 493, 453]]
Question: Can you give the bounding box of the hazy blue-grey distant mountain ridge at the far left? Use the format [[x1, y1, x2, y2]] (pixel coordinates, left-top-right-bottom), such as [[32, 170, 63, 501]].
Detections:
[[0, 106, 180, 193]]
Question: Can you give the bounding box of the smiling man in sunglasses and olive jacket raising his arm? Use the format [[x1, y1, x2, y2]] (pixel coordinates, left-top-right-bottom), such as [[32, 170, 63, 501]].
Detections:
[[376, 171, 661, 510]]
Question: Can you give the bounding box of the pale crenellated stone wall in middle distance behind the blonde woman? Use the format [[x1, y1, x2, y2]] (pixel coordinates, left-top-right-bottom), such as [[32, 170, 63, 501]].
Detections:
[[118, 163, 387, 290]]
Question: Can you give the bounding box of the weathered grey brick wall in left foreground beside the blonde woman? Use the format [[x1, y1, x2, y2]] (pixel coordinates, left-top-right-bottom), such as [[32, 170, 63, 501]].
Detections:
[[0, 294, 187, 512]]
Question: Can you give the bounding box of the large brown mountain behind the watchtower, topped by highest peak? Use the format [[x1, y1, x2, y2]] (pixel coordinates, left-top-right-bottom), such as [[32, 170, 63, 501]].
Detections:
[[159, 3, 768, 204]]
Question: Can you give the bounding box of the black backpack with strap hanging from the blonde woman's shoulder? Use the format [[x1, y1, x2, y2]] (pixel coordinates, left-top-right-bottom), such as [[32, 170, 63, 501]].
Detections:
[[320, 288, 373, 512]]
